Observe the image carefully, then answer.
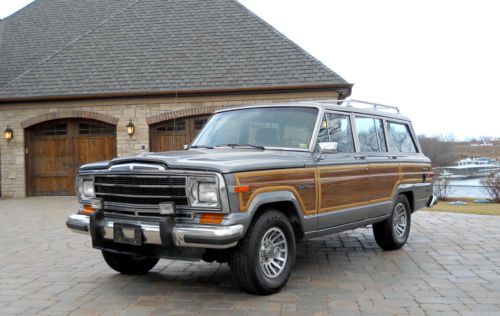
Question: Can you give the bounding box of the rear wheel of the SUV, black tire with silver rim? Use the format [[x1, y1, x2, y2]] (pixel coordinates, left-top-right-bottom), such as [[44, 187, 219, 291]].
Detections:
[[373, 195, 411, 250]]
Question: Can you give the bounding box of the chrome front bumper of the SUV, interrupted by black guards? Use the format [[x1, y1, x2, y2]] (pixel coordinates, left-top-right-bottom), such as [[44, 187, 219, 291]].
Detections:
[[66, 214, 243, 249]]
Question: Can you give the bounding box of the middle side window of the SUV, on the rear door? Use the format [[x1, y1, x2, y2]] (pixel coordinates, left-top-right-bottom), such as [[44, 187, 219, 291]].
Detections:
[[356, 117, 387, 152]]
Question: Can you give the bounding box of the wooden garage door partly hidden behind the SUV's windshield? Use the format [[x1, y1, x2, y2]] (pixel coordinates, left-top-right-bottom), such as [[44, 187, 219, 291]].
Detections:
[[150, 115, 209, 152]]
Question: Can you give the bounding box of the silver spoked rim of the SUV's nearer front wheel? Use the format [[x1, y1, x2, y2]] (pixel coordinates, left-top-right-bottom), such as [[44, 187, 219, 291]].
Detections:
[[259, 227, 288, 279]]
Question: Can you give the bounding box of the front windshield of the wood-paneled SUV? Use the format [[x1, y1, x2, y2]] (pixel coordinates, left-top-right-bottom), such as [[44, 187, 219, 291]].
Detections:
[[192, 107, 318, 149]]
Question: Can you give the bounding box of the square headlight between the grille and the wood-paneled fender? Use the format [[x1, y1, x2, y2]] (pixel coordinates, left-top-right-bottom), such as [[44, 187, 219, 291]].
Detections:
[[188, 177, 219, 207]]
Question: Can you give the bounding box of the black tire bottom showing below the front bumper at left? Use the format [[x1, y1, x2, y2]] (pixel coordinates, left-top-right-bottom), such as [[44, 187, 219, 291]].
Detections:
[[102, 250, 160, 274]]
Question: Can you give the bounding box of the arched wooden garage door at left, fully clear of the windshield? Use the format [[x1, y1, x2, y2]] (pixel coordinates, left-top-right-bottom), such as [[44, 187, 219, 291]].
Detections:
[[26, 119, 116, 196]]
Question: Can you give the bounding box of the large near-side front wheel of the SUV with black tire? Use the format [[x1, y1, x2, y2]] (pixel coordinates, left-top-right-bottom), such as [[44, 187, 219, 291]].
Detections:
[[229, 209, 296, 295]]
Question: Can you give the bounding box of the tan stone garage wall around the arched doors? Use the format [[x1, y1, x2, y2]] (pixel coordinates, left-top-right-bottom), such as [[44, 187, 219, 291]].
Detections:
[[0, 92, 337, 197]]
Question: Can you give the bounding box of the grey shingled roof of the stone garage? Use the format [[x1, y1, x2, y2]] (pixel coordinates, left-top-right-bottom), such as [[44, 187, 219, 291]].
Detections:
[[0, 0, 351, 101]]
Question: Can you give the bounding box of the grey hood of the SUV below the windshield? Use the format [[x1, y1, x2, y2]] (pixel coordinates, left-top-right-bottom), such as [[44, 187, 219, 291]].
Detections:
[[80, 148, 311, 173]]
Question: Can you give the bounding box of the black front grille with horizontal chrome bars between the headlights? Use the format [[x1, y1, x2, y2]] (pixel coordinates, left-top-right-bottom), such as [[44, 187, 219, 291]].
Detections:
[[94, 175, 189, 215]]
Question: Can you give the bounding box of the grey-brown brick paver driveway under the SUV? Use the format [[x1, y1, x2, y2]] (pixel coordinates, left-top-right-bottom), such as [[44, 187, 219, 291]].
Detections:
[[0, 197, 500, 315]]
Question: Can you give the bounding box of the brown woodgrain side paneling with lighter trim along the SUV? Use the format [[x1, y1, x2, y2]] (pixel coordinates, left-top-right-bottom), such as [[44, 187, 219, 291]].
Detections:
[[235, 163, 432, 215]]
